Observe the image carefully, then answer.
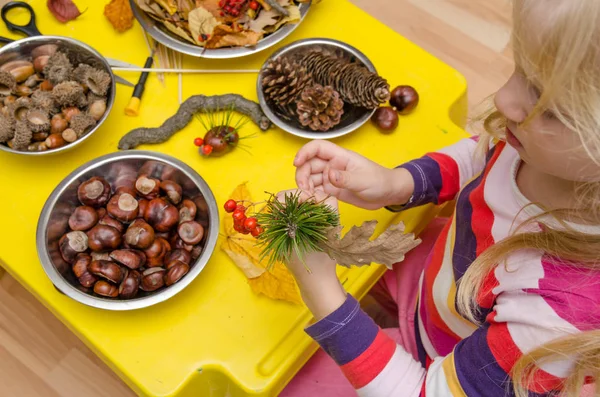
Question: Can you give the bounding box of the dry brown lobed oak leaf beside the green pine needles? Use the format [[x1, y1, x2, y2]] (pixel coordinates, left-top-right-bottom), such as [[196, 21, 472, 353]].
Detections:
[[322, 221, 421, 269]]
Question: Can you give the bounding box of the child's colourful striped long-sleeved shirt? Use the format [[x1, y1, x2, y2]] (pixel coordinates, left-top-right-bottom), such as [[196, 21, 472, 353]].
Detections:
[[306, 139, 600, 397]]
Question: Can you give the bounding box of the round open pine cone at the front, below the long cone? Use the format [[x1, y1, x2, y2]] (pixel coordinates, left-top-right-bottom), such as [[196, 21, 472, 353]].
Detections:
[[296, 84, 344, 132]]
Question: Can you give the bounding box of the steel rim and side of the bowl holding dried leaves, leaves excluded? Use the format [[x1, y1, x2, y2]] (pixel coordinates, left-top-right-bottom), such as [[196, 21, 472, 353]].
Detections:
[[129, 0, 310, 59]]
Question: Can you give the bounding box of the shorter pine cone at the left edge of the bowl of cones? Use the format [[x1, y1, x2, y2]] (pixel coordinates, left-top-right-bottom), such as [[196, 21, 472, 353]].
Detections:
[[262, 57, 310, 108]]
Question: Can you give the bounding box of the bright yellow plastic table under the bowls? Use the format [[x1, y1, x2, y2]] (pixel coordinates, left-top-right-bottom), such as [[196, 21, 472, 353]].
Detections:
[[0, 0, 467, 397]]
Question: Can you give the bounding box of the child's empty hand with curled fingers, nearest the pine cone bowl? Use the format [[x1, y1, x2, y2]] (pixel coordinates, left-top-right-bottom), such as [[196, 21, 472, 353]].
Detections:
[[294, 140, 414, 209]]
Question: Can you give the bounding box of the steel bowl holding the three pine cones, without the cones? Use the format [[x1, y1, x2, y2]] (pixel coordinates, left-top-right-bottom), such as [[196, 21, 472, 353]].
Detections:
[[256, 39, 377, 139]]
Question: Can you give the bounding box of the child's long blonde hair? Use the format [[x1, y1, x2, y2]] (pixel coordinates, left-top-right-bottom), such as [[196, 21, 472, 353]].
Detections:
[[457, 0, 600, 397]]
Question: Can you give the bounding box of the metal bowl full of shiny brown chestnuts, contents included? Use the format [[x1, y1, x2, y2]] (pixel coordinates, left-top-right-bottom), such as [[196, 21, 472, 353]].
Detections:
[[37, 151, 219, 310]]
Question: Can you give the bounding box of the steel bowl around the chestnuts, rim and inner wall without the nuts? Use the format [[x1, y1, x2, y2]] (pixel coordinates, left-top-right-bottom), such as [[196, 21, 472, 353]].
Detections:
[[36, 151, 219, 310]]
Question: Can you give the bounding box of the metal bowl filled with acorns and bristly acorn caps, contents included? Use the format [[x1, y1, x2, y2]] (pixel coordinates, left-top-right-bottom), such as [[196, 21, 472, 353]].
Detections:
[[0, 36, 115, 155]]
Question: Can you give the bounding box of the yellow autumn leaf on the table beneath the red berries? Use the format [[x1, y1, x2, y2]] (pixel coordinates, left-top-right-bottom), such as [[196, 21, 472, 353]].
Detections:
[[221, 183, 302, 304]]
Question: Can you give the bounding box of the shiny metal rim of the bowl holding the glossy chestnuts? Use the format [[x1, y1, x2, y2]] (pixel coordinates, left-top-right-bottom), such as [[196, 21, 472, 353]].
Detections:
[[36, 150, 219, 311]]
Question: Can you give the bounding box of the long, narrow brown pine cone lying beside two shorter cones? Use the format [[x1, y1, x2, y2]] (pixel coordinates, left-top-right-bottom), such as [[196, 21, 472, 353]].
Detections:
[[300, 51, 390, 109]]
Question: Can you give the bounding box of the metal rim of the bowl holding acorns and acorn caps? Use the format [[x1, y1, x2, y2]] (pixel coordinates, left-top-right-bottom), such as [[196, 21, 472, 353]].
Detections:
[[0, 36, 116, 156]]
